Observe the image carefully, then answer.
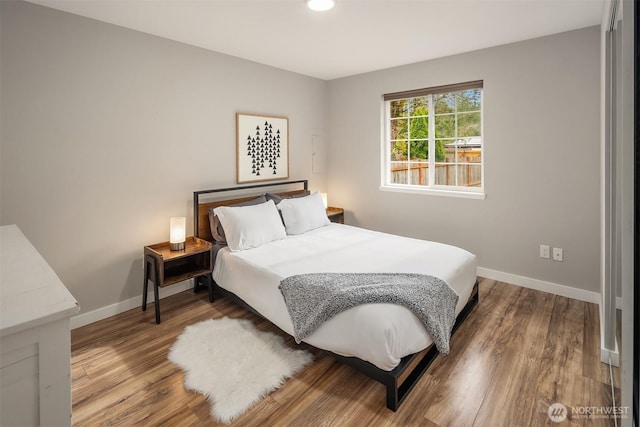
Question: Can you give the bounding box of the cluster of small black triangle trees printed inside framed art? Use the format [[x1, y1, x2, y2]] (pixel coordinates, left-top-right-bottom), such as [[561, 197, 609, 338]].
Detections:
[[247, 120, 281, 176]]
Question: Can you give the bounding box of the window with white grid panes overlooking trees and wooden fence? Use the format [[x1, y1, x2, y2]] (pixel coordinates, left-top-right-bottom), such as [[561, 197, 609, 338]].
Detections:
[[382, 81, 484, 196]]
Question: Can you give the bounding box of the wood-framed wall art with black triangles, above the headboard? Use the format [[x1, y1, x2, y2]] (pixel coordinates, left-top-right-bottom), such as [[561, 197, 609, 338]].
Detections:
[[236, 113, 289, 183]]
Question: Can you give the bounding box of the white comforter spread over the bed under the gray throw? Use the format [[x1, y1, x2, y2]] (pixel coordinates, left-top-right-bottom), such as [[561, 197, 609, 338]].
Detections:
[[213, 223, 476, 370]]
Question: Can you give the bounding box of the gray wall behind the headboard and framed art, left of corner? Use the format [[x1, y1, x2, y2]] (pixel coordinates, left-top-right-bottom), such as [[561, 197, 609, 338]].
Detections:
[[0, 1, 327, 312]]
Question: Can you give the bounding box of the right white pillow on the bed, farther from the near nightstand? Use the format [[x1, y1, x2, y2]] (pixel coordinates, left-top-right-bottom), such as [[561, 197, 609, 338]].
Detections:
[[278, 193, 331, 234]]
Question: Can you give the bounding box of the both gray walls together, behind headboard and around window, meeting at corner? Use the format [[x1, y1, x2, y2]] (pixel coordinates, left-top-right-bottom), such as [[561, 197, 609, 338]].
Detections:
[[0, 1, 600, 318]]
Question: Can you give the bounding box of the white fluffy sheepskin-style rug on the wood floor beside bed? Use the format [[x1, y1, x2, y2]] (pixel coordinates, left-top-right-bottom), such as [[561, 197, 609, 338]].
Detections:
[[169, 317, 312, 424]]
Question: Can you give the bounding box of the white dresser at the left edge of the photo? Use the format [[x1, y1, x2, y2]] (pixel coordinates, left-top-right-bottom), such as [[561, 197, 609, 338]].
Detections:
[[0, 225, 80, 427]]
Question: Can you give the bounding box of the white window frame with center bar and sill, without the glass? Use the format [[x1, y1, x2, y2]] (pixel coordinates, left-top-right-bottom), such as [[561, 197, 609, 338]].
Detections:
[[380, 82, 486, 199]]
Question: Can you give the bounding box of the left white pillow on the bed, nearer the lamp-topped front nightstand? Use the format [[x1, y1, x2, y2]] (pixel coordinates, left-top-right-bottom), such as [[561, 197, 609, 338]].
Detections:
[[213, 200, 287, 252]]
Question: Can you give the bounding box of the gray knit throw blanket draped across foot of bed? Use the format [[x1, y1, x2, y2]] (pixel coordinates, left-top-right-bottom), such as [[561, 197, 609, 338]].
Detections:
[[280, 273, 458, 354]]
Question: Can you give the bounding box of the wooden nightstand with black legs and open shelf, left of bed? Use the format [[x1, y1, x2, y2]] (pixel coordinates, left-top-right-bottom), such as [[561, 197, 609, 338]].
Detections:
[[142, 236, 213, 323]]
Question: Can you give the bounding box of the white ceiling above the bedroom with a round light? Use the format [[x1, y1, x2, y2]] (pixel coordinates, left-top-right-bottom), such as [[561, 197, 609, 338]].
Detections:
[[29, 0, 604, 80]]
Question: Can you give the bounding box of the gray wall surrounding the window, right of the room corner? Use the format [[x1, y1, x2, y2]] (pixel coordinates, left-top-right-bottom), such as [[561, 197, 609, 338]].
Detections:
[[328, 26, 600, 292]]
